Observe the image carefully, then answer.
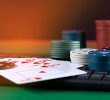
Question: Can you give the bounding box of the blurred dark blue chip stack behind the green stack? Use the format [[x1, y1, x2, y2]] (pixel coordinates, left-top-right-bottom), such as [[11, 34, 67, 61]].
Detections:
[[62, 30, 86, 48]]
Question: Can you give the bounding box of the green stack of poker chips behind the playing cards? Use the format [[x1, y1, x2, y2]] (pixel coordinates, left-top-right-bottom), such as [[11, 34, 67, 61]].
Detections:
[[50, 40, 80, 60]]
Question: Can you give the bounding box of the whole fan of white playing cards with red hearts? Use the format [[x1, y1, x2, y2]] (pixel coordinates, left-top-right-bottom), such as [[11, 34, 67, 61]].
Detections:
[[0, 58, 86, 84]]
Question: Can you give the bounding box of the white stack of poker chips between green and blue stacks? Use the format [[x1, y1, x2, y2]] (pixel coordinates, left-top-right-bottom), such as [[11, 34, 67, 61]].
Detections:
[[70, 48, 96, 65]]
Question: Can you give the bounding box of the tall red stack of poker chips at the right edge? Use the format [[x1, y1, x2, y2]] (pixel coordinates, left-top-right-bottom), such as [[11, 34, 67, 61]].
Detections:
[[95, 20, 110, 49]]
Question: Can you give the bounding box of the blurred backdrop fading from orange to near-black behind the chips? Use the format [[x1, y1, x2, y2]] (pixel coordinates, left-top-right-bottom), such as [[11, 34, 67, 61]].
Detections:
[[0, 0, 110, 40]]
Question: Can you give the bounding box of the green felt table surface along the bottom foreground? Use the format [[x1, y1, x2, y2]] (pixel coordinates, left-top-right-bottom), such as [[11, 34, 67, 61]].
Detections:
[[0, 86, 110, 100]]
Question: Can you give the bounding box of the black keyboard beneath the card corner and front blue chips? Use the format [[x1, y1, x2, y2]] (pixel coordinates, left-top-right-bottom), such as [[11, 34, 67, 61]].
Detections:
[[51, 66, 110, 90]]
